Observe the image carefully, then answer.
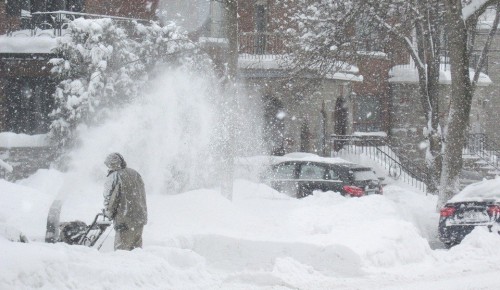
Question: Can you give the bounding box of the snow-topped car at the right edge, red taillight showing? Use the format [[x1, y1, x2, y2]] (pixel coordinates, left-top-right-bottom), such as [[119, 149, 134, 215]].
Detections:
[[438, 179, 500, 248]]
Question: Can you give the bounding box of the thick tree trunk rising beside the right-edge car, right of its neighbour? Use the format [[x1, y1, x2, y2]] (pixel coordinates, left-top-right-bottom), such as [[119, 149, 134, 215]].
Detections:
[[437, 0, 472, 209]]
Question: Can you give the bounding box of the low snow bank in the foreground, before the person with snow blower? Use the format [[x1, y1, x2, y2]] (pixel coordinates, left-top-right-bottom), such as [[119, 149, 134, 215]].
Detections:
[[0, 239, 218, 289]]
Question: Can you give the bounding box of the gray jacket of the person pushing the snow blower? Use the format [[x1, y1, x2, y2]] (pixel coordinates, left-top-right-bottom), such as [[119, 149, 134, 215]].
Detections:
[[104, 168, 148, 228]]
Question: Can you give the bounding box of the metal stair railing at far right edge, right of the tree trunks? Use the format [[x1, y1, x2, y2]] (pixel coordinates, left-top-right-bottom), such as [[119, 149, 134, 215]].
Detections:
[[462, 133, 500, 170]]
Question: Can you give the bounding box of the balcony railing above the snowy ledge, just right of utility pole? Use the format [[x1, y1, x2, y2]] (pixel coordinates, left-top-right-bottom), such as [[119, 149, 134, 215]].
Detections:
[[239, 32, 290, 57]]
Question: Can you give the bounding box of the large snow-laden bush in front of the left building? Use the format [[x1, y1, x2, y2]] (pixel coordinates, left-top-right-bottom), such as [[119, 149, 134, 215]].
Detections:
[[50, 18, 195, 146]]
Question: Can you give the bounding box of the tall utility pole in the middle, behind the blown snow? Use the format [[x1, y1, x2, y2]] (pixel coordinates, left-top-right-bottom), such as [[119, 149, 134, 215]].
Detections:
[[221, 0, 238, 200]]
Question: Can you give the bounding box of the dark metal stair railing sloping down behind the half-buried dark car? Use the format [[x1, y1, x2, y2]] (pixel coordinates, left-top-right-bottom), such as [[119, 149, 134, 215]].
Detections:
[[331, 135, 429, 192]]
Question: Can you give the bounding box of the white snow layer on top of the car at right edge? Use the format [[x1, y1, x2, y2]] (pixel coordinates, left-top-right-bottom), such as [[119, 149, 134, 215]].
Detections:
[[449, 178, 500, 202]]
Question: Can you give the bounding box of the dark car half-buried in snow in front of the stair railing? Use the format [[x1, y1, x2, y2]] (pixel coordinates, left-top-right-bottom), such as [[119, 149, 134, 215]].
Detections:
[[263, 157, 382, 198]]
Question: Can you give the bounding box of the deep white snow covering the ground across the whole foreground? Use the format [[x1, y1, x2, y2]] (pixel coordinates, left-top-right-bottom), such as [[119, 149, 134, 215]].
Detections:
[[0, 176, 500, 289]]
